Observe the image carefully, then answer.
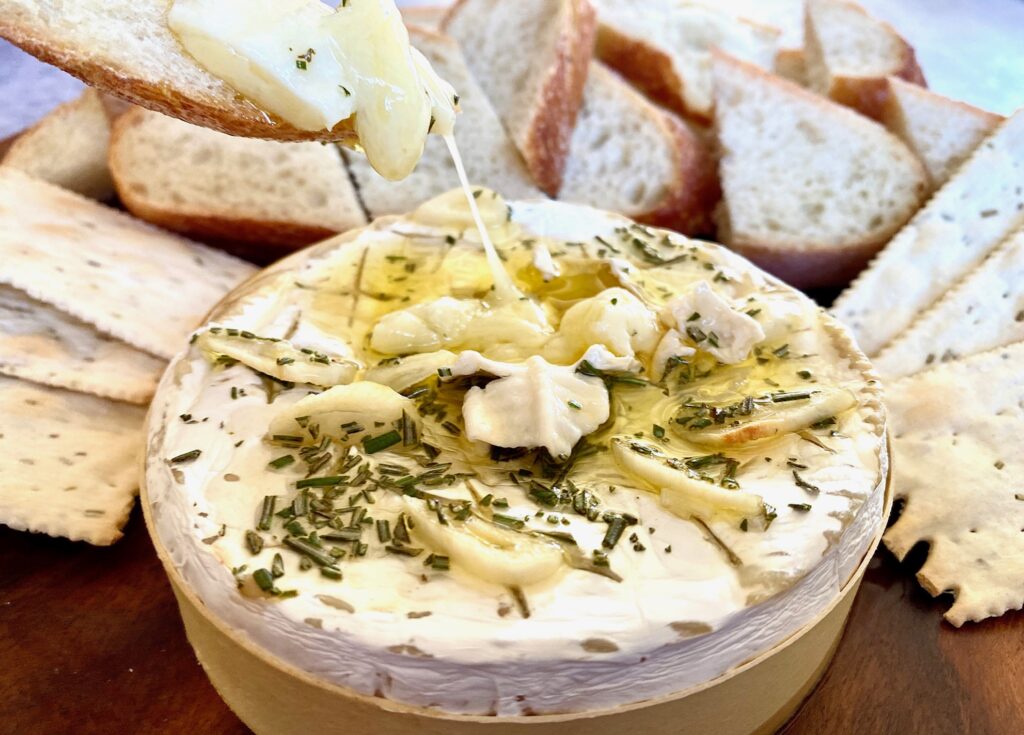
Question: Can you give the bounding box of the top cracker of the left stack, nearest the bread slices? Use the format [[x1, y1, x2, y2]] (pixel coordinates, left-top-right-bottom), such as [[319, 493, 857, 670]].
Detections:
[[0, 168, 254, 358]]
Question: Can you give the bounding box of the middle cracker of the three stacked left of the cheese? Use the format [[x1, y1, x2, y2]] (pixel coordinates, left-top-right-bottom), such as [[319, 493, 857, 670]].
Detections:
[[0, 286, 166, 404]]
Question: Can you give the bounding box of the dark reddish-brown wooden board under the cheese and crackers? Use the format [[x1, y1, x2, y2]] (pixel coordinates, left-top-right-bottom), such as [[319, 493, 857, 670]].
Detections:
[[0, 509, 1024, 735]]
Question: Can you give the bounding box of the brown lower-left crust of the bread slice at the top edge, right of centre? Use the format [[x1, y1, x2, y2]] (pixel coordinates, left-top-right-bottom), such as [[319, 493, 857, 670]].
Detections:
[[596, 25, 692, 123]]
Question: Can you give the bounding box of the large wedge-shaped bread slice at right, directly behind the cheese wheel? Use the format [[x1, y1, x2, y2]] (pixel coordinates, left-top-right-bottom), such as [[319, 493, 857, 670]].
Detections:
[[714, 53, 927, 288]]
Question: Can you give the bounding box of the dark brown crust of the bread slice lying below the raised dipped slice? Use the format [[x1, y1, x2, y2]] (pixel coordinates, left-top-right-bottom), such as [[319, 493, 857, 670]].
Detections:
[[110, 109, 348, 255]]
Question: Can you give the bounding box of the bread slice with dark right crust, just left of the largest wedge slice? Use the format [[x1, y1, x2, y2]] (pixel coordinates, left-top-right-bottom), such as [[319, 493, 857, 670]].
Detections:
[[558, 61, 719, 234]]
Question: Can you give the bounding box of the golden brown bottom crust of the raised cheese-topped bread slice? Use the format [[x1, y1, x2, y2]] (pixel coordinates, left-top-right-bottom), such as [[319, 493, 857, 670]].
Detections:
[[0, 17, 357, 144]]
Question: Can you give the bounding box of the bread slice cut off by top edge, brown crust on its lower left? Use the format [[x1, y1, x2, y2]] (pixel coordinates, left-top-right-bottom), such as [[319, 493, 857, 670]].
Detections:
[[592, 0, 779, 123]]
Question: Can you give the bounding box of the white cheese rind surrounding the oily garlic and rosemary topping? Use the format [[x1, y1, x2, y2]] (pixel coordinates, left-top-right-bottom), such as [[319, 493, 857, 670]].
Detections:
[[146, 195, 887, 715]]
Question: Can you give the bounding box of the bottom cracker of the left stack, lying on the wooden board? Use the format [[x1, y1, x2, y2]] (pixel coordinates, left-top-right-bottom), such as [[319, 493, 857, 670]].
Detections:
[[0, 377, 145, 546]]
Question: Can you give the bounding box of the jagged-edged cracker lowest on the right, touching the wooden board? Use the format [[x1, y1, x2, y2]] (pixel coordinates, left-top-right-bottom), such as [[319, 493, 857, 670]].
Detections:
[[885, 343, 1024, 628]]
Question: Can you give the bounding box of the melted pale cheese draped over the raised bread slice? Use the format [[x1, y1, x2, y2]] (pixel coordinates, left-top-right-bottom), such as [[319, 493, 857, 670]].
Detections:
[[167, 0, 456, 179]]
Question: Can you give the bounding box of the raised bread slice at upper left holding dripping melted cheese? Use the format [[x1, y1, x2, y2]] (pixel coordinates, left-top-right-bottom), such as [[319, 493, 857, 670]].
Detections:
[[0, 0, 356, 142]]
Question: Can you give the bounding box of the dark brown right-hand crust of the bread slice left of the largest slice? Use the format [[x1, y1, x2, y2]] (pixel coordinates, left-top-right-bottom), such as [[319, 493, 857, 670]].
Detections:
[[635, 111, 722, 235]]
